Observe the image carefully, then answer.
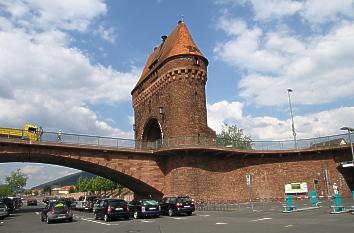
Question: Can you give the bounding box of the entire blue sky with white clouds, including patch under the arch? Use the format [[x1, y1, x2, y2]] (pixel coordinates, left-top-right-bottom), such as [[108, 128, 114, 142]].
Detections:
[[0, 0, 354, 187]]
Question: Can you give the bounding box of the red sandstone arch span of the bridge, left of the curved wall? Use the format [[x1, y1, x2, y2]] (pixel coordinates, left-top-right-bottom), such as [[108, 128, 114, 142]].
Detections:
[[0, 141, 164, 198]]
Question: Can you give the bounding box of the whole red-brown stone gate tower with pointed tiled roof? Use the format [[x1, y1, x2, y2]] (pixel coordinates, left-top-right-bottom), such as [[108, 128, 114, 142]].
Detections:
[[131, 21, 215, 141]]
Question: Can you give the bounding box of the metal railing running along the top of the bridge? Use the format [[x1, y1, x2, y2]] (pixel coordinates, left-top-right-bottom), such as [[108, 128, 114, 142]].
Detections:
[[0, 128, 354, 151]]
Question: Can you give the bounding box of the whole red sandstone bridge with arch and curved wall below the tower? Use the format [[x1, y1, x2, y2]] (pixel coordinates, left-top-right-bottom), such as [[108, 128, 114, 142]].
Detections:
[[0, 138, 354, 202]]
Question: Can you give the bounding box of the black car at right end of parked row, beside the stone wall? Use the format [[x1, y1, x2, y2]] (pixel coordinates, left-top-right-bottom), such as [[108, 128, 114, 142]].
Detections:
[[160, 197, 195, 216]]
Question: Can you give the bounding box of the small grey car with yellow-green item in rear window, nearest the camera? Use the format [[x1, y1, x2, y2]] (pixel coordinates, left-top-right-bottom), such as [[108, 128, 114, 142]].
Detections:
[[41, 201, 73, 224]]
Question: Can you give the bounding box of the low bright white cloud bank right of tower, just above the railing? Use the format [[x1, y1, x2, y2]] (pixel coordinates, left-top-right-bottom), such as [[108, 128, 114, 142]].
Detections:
[[207, 101, 354, 140]]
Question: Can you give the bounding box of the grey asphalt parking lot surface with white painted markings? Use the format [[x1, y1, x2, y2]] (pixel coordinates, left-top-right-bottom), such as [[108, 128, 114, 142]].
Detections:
[[0, 202, 354, 233]]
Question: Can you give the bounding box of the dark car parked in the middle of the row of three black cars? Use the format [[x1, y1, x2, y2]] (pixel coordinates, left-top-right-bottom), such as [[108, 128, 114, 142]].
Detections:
[[129, 199, 160, 219]]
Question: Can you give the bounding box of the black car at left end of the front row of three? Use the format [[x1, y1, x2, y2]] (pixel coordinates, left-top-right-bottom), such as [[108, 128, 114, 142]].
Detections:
[[94, 198, 129, 222]]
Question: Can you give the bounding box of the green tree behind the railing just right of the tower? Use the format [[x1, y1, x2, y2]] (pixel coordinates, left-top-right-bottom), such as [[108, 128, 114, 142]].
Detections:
[[216, 124, 252, 150]]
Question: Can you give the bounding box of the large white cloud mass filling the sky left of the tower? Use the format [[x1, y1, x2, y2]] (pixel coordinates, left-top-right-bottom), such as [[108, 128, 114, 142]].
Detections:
[[0, 0, 139, 137]]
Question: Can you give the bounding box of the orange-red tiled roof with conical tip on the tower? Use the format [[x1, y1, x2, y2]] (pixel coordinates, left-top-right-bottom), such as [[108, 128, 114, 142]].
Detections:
[[133, 21, 204, 91]]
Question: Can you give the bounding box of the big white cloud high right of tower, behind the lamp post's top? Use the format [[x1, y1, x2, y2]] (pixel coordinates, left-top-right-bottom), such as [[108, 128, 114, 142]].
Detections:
[[214, 16, 354, 106]]
